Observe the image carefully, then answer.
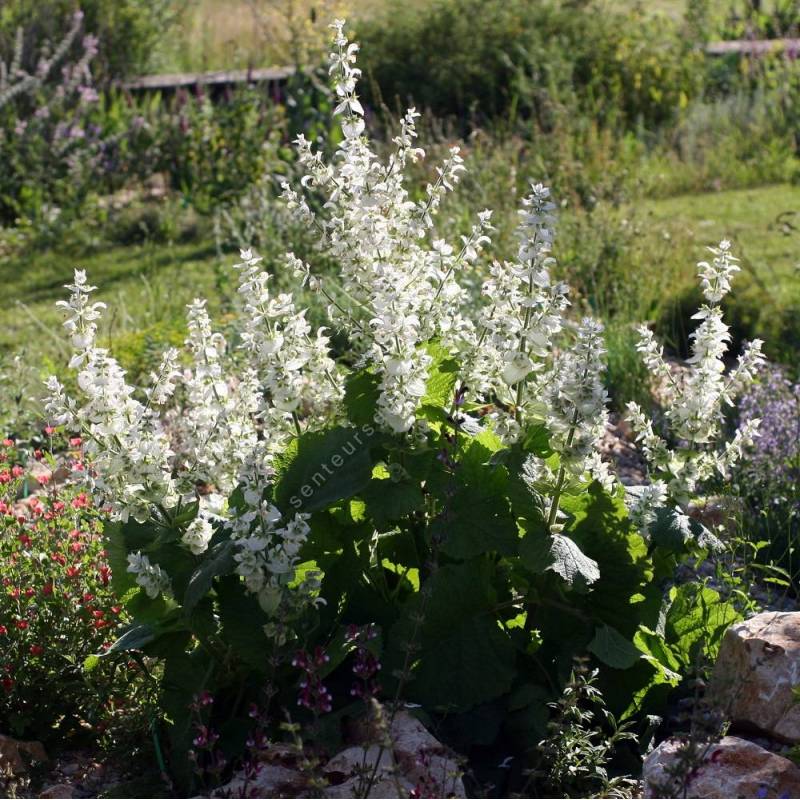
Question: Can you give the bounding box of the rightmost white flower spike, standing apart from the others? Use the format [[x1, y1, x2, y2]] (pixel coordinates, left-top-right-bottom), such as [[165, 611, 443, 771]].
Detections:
[[628, 241, 763, 524]]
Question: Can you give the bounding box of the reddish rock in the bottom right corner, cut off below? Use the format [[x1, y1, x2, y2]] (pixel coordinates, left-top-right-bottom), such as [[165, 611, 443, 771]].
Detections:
[[642, 736, 800, 798]]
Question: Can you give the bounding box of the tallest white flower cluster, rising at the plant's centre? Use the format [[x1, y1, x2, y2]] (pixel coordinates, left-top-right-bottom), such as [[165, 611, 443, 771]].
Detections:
[[284, 20, 491, 433]]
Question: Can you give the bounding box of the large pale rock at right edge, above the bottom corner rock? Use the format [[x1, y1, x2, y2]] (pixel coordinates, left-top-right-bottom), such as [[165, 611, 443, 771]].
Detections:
[[711, 612, 800, 743]]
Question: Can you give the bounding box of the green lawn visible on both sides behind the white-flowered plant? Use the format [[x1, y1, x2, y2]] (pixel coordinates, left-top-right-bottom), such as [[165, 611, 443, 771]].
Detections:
[[0, 184, 800, 374]]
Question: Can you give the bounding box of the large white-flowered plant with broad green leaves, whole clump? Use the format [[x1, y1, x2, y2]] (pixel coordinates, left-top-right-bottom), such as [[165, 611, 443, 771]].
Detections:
[[47, 21, 760, 781]]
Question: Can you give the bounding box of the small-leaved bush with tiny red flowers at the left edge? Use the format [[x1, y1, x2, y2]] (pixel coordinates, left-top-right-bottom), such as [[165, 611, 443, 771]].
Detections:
[[0, 438, 136, 738]]
